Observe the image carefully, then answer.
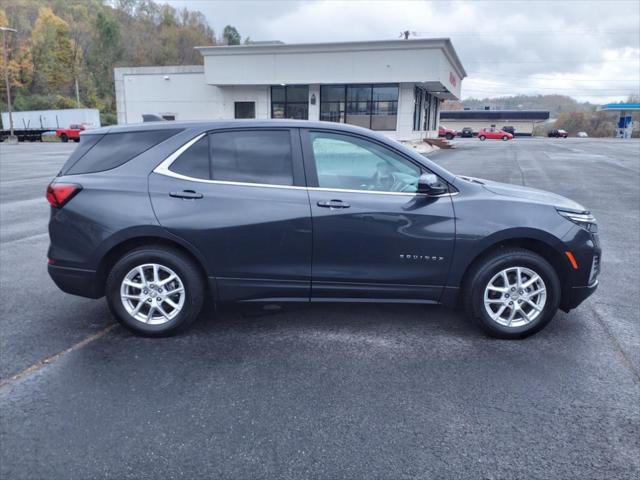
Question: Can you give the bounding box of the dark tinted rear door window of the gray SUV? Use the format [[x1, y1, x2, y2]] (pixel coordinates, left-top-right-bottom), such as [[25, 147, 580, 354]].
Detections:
[[171, 130, 293, 185]]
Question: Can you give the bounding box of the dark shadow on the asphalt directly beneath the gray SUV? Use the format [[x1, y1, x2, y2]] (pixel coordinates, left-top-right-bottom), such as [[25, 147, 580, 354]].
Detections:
[[109, 303, 575, 342]]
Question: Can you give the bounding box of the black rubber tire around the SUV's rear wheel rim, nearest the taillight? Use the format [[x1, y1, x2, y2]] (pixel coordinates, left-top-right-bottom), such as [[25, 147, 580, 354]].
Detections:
[[105, 245, 205, 336]]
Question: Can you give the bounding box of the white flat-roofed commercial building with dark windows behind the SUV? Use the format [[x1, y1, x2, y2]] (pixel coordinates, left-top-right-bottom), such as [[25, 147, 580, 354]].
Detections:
[[115, 39, 466, 140]]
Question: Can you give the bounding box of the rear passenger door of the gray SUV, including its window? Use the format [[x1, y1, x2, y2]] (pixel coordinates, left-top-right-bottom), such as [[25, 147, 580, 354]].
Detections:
[[149, 128, 311, 301]]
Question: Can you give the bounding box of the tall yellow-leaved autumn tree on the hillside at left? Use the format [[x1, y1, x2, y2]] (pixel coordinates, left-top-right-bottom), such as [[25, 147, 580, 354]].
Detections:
[[31, 7, 76, 93]]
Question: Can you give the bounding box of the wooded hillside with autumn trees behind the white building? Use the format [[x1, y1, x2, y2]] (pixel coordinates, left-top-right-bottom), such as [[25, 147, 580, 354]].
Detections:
[[0, 0, 240, 124]]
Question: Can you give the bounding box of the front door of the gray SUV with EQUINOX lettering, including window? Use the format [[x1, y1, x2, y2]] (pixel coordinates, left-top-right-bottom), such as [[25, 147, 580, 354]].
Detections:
[[303, 131, 455, 301]]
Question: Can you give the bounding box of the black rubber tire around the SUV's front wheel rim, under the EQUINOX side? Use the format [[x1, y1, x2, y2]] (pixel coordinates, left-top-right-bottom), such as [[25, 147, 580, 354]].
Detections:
[[463, 248, 561, 339]]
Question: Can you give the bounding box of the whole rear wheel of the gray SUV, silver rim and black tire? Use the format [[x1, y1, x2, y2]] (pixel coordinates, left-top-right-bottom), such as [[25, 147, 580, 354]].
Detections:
[[106, 246, 205, 336]]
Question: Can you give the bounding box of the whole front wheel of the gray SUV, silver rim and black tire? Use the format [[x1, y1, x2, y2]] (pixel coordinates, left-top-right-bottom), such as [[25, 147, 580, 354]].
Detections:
[[465, 248, 560, 339]]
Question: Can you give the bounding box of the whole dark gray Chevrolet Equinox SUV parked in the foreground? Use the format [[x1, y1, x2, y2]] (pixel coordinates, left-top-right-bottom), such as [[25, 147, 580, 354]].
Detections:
[[47, 120, 600, 338]]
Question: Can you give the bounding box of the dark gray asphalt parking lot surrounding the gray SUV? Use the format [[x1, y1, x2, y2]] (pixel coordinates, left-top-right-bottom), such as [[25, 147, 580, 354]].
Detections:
[[0, 138, 640, 479]]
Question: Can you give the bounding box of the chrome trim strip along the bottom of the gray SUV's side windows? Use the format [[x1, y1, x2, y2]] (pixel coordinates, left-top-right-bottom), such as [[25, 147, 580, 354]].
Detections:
[[153, 132, 458, 198]]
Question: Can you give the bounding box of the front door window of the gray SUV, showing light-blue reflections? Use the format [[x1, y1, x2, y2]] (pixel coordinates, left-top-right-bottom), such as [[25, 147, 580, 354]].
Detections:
[[310, 132, 421, 193]]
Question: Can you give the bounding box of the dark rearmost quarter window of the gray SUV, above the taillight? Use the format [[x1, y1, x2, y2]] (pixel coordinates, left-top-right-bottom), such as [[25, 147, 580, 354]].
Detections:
[[60, 129, 181, 175]]
